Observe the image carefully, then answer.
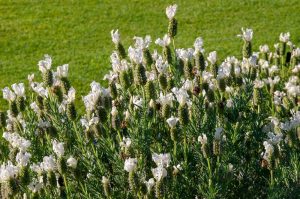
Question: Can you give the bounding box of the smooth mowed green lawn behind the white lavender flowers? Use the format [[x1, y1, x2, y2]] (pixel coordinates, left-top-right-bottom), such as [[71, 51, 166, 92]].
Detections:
[[0, 0, 300, 109]]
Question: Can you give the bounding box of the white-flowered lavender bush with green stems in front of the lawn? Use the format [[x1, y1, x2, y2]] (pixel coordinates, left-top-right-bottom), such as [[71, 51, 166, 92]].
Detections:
[[0, 5, 300, 199]]
